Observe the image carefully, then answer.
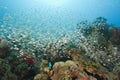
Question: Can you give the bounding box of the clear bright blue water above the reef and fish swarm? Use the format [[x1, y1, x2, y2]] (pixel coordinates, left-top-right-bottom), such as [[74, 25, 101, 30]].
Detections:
[[0, 0, 120, 30]]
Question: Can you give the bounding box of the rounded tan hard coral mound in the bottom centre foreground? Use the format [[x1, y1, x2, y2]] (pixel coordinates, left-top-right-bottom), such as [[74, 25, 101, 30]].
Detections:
[[51, 60, 87, 80]]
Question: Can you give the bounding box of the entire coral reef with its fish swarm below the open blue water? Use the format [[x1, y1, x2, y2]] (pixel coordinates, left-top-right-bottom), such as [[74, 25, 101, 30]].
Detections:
[[0, 17, 120, 80]]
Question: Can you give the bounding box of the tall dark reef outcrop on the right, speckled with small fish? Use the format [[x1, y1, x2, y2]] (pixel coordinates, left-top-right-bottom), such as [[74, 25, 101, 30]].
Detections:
[[78, 17, 120, 71]]
